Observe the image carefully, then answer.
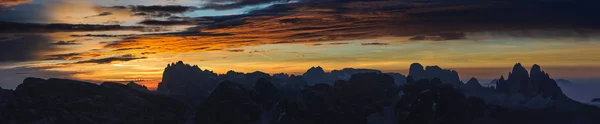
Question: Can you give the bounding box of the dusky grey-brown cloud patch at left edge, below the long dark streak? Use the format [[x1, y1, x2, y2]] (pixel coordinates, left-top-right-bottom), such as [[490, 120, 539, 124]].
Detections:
[[0, 35, 56, 62]]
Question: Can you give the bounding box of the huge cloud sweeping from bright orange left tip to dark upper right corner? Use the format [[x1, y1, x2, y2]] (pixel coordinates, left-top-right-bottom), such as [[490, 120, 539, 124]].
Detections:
[[108, 0, 600, 53]]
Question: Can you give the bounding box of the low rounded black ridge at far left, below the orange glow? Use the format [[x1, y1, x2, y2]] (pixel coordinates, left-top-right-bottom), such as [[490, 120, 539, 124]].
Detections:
[[0, 78, 189, 124]]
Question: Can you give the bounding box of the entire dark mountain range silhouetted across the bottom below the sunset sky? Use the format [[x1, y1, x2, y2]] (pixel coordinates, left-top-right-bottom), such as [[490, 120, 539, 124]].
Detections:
[[0, 62, 600, 124]]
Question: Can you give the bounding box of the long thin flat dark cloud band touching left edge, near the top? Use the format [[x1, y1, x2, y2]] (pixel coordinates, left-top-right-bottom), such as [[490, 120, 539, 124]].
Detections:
[[0, 21, 144, 33]]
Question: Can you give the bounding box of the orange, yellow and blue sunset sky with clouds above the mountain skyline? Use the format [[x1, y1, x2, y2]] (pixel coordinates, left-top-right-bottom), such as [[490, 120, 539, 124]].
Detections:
[[0, 0, 600, 92]]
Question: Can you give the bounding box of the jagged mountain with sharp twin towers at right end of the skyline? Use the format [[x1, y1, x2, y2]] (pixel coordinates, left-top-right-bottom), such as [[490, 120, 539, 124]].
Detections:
[[495, 63, 580, 110]]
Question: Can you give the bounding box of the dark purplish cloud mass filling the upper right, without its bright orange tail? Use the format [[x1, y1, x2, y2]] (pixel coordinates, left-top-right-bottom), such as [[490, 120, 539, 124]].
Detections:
[[197, 0, 600, 39]]
